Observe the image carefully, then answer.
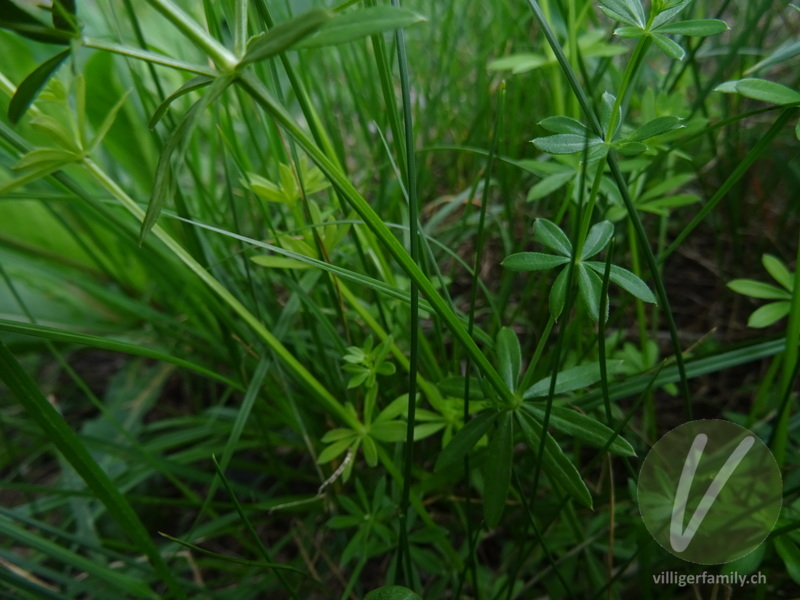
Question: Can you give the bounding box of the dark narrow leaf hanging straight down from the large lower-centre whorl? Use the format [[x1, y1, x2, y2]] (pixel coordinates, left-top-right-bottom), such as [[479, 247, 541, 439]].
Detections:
[[483, 411, 514, 529]]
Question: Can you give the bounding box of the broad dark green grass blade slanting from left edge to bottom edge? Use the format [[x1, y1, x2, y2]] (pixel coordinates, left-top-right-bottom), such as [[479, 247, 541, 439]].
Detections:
[[0, 341, 183, 597]]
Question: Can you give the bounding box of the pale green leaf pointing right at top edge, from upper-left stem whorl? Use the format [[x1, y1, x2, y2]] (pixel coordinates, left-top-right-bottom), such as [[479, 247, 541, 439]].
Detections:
[[297, 6, 427, 48]]
